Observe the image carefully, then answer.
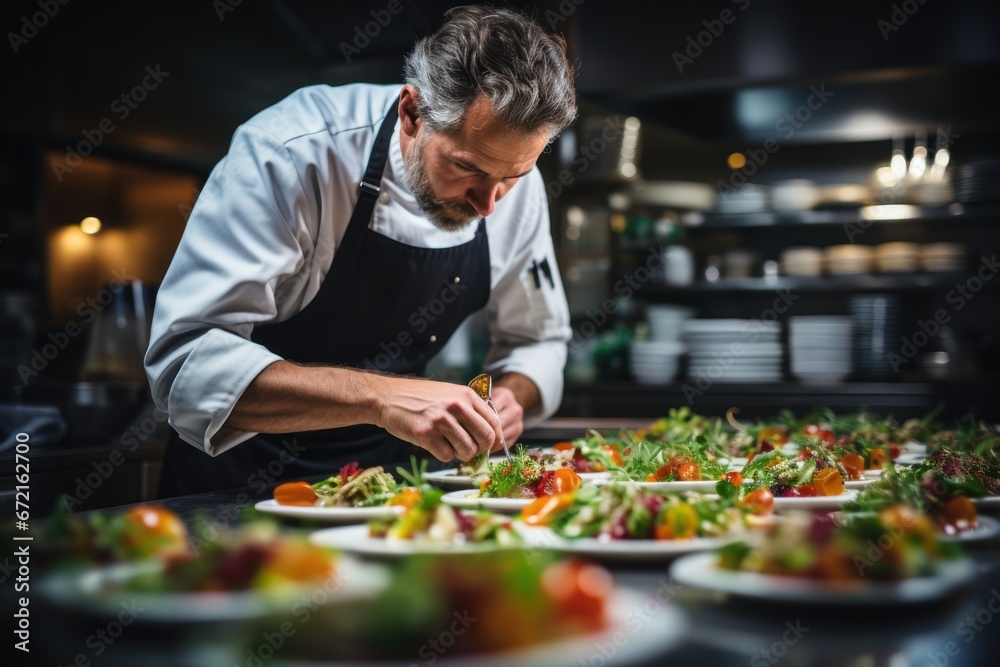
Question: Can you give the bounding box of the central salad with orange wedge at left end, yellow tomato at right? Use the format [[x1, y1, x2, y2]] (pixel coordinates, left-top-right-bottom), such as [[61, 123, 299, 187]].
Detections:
[[520, 484, 752, 540]]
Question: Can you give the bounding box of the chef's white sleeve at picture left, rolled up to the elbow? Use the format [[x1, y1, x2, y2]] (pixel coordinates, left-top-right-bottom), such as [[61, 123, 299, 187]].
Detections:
[[145, 127, 312, 456]]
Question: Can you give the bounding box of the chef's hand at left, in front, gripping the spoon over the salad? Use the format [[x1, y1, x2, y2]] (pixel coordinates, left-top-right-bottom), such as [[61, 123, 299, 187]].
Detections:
[[377, 377, 503, 461]]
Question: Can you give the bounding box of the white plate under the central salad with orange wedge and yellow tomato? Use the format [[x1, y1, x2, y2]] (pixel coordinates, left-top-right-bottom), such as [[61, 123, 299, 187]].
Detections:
[[522, 527, 749, 560]]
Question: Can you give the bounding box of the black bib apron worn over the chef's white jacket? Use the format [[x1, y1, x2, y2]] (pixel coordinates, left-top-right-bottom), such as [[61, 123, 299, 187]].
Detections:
[[158, 98, 490, 498]]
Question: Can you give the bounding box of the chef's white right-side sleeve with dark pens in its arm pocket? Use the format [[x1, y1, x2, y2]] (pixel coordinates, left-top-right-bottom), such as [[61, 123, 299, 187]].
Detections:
[[485, 170, 572, 427]]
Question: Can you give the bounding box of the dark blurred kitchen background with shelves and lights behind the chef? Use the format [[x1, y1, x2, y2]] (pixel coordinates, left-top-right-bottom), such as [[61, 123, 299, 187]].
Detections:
[[0, 0, 1000, 511]]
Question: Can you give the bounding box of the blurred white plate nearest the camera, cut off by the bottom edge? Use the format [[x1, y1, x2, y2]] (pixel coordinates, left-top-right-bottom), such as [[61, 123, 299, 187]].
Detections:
[[274, 587, 690, 667]]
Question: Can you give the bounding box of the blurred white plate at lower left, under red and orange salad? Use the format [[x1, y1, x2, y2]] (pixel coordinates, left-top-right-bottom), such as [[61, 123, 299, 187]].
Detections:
[[41, 556, 389, 624]]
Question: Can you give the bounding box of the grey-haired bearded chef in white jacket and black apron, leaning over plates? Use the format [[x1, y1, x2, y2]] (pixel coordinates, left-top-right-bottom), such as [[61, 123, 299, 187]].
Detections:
[[145, 7, 576, 497]]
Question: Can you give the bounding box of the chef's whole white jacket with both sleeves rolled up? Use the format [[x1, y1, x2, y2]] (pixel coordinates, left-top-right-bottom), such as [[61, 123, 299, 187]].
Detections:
[[145, 84, 571, 456]]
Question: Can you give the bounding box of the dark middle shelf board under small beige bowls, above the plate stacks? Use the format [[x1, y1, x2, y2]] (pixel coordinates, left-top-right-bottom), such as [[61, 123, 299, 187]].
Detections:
[[642, 271, 980, 296]]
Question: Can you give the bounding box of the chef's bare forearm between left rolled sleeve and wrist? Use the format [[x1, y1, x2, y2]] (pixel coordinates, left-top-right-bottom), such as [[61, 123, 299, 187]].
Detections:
[[226, 361, 383, 433]]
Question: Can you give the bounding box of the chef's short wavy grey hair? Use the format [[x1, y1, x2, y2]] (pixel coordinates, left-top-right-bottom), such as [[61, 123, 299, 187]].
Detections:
[[403, 6, 577, 141]]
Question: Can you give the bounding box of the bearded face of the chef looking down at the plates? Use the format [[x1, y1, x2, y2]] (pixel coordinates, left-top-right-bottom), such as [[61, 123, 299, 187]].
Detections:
[[404, 98, 548, 231]]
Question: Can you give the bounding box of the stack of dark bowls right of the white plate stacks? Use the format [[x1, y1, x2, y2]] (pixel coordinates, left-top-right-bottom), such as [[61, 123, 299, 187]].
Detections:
[[851, 294, 901, 380]]
